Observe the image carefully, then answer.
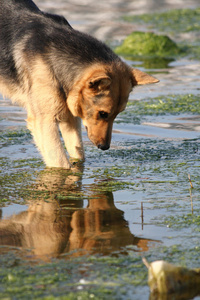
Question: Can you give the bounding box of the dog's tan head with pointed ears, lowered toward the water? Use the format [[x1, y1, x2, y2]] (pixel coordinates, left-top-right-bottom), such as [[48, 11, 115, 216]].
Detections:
[[67, 63, 158, 150]]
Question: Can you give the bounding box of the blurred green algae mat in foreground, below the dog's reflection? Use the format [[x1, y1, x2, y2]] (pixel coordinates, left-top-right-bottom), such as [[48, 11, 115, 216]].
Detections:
[[0, 255, 147, 299]]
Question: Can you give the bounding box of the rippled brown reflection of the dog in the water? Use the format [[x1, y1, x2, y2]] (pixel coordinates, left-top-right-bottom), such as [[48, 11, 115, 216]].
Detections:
[[0, 171, 159, 260]]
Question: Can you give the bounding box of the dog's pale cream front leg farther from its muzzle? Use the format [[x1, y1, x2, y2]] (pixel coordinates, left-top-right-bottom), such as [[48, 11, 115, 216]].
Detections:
[[27, 116, 71, 169]]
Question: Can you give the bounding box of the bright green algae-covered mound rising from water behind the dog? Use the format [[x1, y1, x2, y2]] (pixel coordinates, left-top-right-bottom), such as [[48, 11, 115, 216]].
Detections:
[[115, 32, 182, 57]]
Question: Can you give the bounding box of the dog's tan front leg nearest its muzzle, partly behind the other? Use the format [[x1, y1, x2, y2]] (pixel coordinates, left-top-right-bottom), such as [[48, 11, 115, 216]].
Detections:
[[59, 116, 85, 160]]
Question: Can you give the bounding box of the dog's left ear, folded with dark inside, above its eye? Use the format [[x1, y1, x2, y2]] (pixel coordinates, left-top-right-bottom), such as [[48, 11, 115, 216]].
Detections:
[[88, 74, 111, 93]]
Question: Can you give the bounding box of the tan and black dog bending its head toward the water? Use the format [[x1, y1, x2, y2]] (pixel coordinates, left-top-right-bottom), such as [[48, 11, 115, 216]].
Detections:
[[0, 0, 158, 169]]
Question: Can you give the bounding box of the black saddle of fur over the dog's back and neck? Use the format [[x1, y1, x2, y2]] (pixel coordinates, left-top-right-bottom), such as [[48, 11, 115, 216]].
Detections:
[[0, 0, 119, 92]]
